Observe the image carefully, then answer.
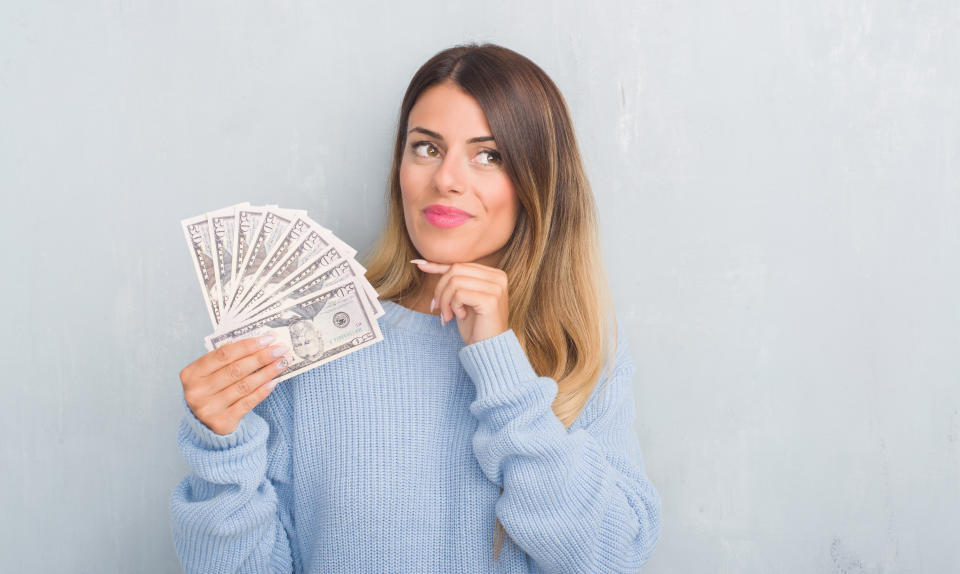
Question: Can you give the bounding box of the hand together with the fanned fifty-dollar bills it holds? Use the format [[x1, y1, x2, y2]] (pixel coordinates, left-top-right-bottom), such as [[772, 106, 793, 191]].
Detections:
[[180, 203, 384, 432]]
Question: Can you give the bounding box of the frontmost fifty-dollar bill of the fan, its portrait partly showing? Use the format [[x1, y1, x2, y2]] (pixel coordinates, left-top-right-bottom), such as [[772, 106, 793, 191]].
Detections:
[[206, 277, 383, 382]]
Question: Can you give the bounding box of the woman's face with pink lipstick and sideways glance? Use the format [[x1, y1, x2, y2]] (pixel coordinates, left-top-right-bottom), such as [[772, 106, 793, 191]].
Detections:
[[400, 83, 519, 266]]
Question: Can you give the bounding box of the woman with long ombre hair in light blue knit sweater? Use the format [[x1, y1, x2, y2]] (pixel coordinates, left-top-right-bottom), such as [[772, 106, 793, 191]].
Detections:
[[171, 44, 660, 573]]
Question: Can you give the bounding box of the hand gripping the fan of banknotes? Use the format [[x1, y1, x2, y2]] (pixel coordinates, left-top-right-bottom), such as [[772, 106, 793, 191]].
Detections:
[[180, 335, 290, 435]]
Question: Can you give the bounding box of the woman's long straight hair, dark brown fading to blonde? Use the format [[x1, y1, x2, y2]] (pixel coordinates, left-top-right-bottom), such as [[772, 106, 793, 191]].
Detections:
[[363, 43, 617, 559]]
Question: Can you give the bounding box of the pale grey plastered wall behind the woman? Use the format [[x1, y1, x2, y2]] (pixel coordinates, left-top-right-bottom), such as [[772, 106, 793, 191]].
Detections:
[[0, 0, 960, 573]]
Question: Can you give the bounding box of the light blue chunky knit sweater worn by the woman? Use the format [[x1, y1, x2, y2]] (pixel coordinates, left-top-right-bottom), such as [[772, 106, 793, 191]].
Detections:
[[170, 301, 660, 574]]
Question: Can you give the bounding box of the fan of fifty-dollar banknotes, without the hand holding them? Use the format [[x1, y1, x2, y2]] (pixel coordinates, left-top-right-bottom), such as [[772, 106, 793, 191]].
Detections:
[[180, 203, 384, 388]]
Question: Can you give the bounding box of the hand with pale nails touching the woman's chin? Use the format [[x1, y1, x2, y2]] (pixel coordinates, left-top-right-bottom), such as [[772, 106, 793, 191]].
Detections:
[[417, 262, 510, 345]]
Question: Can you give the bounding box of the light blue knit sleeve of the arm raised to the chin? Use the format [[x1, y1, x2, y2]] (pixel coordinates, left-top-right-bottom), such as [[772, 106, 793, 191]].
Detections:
[[459, 329, 660, 574]]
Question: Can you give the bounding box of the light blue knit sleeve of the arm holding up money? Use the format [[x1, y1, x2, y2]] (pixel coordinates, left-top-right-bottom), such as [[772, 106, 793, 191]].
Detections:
[[170, 384, 299, 574]]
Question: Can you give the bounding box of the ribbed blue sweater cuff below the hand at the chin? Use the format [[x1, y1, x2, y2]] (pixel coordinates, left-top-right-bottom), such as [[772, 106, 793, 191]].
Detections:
[[458, 329, 537, 398]]
